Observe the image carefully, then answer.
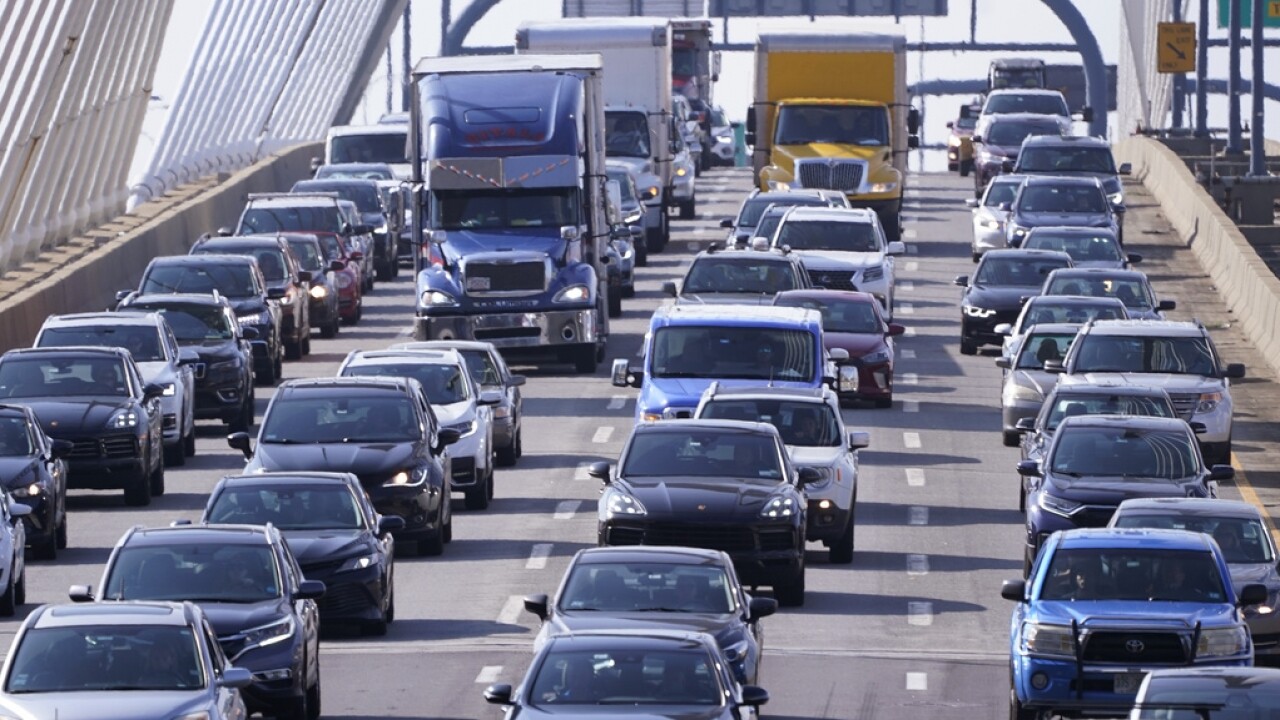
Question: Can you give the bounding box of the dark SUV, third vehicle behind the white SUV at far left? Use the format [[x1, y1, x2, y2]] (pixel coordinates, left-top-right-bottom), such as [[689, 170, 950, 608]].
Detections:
[[191, 234, 311, 360]]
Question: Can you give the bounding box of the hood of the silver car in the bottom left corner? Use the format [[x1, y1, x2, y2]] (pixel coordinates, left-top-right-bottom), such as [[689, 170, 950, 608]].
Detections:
[[0, 688, 209, 720]]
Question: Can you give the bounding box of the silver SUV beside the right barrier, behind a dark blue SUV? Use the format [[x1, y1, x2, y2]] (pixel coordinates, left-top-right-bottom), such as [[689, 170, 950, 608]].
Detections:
[[1044, 320, 1244, 465]]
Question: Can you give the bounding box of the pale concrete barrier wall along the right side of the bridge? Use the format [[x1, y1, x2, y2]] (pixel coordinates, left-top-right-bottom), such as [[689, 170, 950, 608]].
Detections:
[[1115, 136, 1280, 373]]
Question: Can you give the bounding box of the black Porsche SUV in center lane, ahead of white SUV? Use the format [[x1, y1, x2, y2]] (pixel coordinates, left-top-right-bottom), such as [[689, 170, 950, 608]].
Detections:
[[589, 420, 818, 606]]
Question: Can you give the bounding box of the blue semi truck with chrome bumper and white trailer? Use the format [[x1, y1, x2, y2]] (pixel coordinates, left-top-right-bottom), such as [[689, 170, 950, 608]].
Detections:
[[410, 54, 611, 373]]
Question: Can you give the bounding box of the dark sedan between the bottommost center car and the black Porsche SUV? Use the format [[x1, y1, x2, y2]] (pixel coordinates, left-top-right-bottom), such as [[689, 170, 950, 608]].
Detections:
[[525, 547, 778, 683]]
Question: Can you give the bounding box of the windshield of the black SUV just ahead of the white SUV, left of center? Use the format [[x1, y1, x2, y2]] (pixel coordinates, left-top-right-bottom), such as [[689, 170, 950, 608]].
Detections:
[[261, 388, 424, 443]]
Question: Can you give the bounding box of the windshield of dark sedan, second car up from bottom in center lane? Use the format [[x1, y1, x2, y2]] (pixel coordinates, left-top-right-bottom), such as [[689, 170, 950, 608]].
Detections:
[[558, 562, 737, 615]]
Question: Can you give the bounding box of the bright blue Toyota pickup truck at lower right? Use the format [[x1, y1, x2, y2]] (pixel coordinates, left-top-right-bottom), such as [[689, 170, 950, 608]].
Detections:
[[1001, 528, 1267, 720]]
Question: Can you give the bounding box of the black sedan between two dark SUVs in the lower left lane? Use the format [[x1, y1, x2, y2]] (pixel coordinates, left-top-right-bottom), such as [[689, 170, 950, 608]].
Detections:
[[200, 473, 404, 635]]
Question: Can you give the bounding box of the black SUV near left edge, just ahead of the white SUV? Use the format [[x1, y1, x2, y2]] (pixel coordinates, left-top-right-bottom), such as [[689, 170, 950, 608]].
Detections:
[[0, 347, 164, 506]]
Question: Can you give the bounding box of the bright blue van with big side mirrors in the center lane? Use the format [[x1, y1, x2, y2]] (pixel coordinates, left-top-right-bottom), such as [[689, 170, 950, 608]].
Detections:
[[612, 305, 858, 423]]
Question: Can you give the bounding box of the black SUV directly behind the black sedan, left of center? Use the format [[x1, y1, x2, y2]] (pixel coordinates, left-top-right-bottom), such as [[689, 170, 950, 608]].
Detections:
[[227, 377, 461, 555]]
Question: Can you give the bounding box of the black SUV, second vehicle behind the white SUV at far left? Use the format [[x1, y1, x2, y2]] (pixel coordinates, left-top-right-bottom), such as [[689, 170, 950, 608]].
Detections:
[[115, 255, 284, 384]]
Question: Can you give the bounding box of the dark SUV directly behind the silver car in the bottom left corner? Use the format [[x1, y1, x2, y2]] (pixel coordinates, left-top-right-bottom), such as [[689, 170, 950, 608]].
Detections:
[[69, 525, 325, 717]]
